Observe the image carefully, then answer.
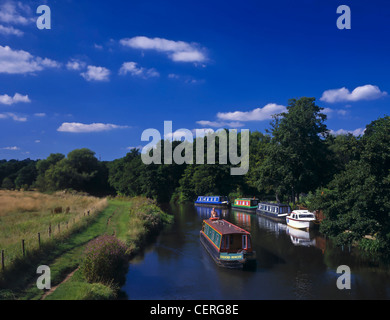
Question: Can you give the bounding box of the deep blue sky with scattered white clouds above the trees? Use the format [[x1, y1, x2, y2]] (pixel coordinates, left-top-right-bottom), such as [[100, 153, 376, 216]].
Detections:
[[0, 0, 390, 160]]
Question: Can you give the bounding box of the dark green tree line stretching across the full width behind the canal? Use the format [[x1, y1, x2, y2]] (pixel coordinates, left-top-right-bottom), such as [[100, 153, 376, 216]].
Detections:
[[0, 97, 390, 251]]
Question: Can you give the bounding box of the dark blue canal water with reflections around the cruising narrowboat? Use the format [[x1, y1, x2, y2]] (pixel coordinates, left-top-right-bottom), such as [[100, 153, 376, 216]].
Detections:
[[122, 204, 390, 300]]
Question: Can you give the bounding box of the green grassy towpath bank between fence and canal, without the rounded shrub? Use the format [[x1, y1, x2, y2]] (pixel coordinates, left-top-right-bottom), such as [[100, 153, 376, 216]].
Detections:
[[0, 192, 172, 300]]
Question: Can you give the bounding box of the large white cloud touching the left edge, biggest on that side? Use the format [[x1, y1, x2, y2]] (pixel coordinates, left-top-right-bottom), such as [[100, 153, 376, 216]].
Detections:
[[0, 45, 60, 74]]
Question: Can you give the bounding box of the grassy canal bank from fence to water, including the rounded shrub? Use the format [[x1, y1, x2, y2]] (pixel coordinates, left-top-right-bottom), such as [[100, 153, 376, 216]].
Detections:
[[0, 195, 172, 300]]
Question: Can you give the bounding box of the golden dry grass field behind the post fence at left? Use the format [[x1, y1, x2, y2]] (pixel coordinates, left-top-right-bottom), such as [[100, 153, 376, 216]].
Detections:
[[0, 190, 107, 268]]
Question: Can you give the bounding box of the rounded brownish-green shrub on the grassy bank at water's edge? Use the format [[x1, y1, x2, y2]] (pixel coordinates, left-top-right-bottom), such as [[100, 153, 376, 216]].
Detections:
[[81, 235, 128, 283]]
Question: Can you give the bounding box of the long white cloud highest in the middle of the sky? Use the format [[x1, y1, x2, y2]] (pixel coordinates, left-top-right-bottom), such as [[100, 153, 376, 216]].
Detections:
[[120, 36, 207, 62]]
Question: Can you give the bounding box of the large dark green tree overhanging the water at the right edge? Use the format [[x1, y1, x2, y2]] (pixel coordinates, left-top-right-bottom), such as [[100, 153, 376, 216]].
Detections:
[[311, 116, 390, 252]]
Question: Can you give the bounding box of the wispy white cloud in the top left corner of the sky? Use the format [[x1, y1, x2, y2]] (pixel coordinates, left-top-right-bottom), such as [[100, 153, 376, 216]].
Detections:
[[0, 1, 35, 25]]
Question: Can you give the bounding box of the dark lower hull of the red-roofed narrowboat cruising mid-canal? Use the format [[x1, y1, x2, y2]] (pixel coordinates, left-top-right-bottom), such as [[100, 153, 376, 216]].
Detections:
[[199, 231, 256, 269]]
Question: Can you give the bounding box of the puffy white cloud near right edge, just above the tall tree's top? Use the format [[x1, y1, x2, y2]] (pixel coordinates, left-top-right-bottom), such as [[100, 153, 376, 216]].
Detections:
[[320, 84, 387, 103]]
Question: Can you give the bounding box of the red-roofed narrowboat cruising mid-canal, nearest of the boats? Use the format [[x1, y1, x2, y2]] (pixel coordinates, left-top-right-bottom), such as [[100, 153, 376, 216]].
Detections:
[[200, 219, 256, 269]]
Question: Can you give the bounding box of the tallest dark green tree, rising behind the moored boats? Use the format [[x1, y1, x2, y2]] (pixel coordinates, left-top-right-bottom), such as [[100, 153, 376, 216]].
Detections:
[[259, 97, 328, 202]]
